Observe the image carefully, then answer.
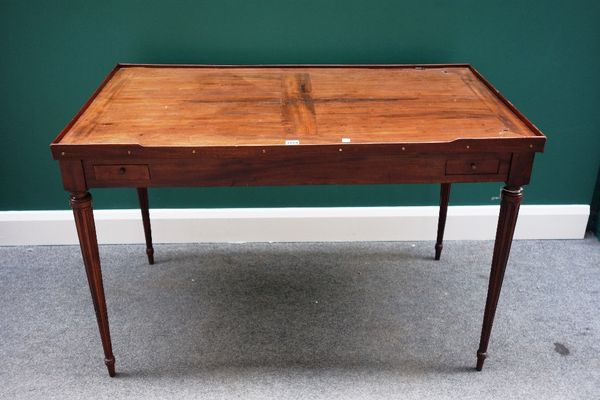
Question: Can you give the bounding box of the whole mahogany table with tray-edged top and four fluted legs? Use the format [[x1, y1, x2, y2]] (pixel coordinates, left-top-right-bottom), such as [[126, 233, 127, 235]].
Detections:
[[50, 64, 546, 376]]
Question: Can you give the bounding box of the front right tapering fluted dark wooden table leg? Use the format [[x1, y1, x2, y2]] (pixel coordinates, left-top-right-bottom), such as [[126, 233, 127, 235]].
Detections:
[[476, 186, 523, 371]]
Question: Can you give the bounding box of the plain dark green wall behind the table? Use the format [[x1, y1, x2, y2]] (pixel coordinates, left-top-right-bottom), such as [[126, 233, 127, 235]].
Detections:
[[0, 0, 600, 210]]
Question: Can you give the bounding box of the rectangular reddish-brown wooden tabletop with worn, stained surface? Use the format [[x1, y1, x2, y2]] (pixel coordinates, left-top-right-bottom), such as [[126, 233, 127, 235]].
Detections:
[[54, 65, 545, 147]]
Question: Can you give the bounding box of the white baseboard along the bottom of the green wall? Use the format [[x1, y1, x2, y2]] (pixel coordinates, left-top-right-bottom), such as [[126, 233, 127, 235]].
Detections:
[[0, 204, 590, 246]]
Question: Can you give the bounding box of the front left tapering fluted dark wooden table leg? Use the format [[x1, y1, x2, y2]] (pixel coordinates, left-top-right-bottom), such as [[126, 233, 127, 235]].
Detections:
[[71, 192, 115, 377]]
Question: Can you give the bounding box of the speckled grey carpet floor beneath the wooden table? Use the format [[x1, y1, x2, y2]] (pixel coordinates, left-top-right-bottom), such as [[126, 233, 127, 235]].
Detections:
[[0, 237, 600, 399]]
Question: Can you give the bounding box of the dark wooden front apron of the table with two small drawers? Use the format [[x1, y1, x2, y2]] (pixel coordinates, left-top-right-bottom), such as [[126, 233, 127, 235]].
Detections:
[[81, 152, 512, 188]]
